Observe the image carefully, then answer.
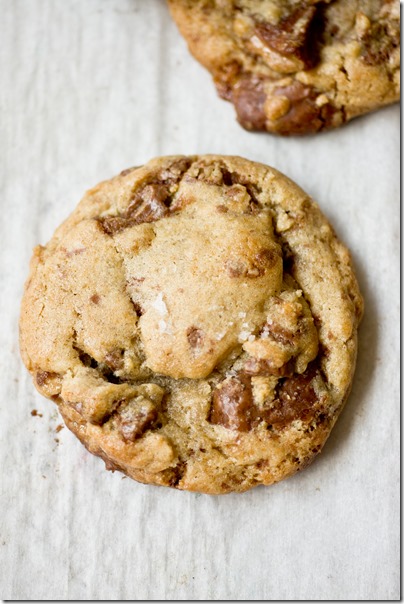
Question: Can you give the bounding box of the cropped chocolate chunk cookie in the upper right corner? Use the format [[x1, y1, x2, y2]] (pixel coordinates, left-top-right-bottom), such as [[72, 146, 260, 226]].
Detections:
[[168, 0, 400, 135]]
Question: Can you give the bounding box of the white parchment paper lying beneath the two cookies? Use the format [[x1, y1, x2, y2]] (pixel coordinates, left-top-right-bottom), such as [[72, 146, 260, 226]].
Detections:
[[0, 0, 399, 600]]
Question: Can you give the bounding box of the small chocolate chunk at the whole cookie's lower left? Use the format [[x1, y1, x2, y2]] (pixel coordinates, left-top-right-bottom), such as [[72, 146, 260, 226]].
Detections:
[[117, 397, 158, 442]]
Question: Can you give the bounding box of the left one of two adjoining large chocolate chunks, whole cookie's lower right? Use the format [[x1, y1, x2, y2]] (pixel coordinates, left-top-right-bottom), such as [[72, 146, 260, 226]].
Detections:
[[210, 374, 254, 432]]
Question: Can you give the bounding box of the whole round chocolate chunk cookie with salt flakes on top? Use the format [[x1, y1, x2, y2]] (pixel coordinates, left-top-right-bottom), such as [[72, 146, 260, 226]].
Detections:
[[20, 155, 363, 493]]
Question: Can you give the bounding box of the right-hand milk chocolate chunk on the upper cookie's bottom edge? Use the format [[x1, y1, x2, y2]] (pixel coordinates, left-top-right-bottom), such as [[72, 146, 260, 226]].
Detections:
[[273, 80, 335, 134]]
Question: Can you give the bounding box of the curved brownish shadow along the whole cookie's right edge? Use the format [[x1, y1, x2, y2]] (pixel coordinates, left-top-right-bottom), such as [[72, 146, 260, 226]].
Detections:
[[316, 249, 379, 464]]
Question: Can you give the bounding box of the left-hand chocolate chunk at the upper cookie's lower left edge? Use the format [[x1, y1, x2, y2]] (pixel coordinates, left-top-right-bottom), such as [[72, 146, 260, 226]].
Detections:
[[232, 75, 267, 130]]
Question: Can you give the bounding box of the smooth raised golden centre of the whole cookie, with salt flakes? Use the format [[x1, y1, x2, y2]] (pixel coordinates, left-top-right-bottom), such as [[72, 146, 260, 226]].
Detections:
[[109, 172, 282, 378]]
